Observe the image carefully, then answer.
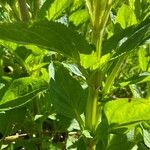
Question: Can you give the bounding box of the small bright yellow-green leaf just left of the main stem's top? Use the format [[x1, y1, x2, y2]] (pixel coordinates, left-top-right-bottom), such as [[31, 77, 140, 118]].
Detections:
[[69, 9, 89, 26]]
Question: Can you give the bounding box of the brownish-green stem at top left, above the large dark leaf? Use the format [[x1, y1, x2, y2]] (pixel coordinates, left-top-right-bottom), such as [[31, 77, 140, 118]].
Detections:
[[18, 0, 30, 21]]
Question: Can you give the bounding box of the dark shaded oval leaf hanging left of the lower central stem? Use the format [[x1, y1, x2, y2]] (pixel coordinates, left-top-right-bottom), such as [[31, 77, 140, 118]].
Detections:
[[50, 67, 86, 118]]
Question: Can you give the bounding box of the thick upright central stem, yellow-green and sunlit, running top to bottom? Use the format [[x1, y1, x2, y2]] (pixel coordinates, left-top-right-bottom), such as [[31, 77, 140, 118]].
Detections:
[[85, 0, 112, 150]]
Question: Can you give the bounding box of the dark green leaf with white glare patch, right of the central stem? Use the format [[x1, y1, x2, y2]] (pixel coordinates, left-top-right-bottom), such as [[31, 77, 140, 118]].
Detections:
[[103, 19, 150, 57]]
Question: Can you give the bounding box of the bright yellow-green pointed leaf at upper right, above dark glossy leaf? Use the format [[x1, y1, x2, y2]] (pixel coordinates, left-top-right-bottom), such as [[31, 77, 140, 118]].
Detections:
[[115, 4, 137, 29]]
